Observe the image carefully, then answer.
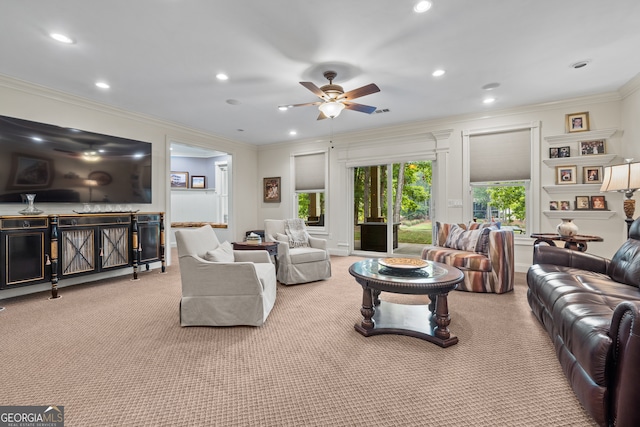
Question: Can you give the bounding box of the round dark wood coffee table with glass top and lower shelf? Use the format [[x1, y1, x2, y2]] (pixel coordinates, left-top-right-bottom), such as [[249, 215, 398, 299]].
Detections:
[[349, 258, 464, 347]]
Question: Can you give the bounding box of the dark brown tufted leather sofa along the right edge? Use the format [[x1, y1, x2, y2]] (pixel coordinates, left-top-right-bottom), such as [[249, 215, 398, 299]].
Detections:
[[527, 219, 640, 427]]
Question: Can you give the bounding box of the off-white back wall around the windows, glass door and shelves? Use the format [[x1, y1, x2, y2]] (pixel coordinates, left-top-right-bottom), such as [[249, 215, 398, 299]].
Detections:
[[258, 78, 640, 271]]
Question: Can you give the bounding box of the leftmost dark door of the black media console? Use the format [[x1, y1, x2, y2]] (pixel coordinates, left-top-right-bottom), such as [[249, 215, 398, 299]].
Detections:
[[1, 230, 50, 288]]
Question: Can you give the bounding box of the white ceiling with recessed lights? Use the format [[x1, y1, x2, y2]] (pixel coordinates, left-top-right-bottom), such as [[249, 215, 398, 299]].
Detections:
[[0, 0, 640, 145]]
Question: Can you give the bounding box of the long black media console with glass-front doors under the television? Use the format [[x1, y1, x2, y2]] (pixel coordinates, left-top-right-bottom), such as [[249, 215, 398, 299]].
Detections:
[[0, 212, 166, 298]]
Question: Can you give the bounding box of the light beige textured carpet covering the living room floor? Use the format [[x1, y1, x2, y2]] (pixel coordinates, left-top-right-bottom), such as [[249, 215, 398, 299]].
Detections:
[[0, 256, 594, 427]]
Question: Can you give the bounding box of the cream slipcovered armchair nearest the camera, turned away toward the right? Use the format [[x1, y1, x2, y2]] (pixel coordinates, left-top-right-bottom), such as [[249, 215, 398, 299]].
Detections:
[[176, 225, 277, 326]]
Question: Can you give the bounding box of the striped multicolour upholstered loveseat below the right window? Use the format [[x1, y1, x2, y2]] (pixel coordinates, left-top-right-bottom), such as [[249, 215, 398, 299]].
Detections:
[[422, 222, 514, 294]]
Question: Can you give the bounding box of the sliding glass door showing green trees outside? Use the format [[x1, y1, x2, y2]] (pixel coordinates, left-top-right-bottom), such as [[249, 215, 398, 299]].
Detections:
[[353, 161, 432, 256]]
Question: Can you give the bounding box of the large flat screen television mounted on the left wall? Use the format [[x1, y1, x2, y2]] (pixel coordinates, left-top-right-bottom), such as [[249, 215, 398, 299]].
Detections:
[[0, 116, 151, 204]]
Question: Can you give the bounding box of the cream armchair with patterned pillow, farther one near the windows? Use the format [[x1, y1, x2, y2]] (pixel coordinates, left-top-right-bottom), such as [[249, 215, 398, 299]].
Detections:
[[264, 219, 331, 285]]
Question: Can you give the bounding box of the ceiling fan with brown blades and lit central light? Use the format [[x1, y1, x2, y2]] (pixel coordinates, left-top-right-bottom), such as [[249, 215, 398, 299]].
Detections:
[[290, 71, 380, 120]]
